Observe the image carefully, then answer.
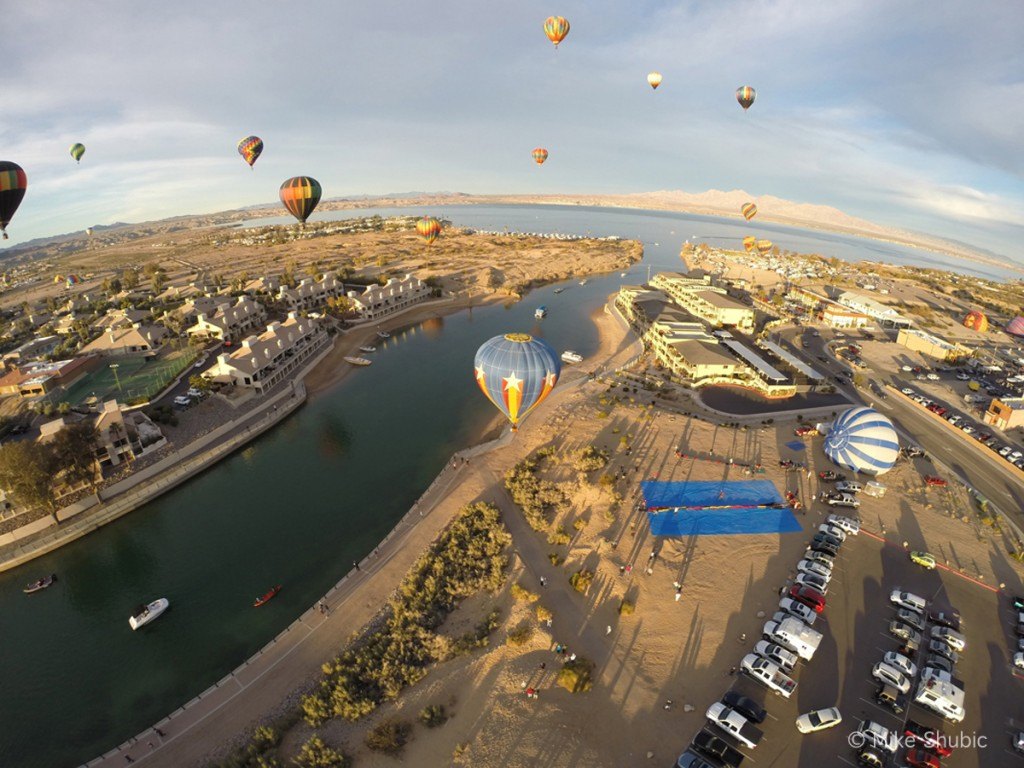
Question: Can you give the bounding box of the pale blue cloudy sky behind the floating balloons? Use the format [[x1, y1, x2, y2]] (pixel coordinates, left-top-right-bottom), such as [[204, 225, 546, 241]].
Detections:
[[0, 0, 1024, 263]]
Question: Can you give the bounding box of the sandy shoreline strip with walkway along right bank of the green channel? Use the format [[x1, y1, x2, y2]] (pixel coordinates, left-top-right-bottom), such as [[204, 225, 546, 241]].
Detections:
[[82, 296, 636, 768]]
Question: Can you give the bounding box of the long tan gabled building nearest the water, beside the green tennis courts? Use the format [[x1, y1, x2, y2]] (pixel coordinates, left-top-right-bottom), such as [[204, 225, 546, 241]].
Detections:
[[204, 312, 330, 393]]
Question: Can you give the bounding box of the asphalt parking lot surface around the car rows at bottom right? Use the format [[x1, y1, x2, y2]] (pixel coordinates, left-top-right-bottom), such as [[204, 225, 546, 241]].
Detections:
[[679, 520, 1024, 768]]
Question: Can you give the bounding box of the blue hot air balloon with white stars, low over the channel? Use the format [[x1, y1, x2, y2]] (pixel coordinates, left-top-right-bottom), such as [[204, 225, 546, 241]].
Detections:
[[473, 334, 562, 431]]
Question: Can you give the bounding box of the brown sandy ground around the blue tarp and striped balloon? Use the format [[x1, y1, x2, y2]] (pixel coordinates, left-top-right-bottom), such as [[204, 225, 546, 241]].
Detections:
[[249, 309, 1024, 768]]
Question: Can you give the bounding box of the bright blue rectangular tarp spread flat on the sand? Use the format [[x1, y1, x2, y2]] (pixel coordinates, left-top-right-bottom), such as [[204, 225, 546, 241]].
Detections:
[[640, 480, 802, 537]]
